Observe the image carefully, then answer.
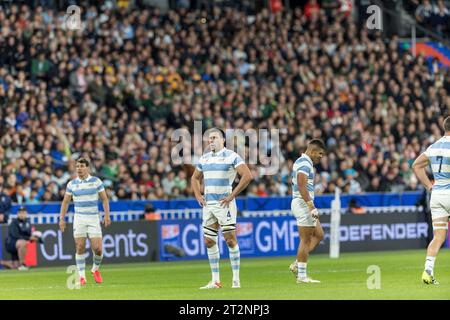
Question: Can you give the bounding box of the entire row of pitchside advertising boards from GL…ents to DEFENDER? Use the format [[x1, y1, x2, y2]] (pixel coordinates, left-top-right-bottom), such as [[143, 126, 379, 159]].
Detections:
[[0, 213, 449, 267]]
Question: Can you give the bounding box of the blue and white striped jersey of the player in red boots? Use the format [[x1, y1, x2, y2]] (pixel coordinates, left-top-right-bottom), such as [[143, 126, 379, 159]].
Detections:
[[66, 175, 105, 216]]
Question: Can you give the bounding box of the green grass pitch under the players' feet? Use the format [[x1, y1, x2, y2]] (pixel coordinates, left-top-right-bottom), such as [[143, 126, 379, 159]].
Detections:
[[0, 249, 450, 300]]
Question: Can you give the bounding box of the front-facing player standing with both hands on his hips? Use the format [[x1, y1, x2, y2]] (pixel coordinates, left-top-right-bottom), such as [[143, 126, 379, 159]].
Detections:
[[191, 128, 252, 289]]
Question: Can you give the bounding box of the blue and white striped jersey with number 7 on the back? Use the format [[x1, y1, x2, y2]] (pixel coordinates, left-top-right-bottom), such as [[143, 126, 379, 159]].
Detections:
[[424, 136, 450, 193]]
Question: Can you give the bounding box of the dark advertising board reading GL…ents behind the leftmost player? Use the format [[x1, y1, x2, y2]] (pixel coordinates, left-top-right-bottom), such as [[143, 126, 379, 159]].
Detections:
[[0, 220, 159, 267]]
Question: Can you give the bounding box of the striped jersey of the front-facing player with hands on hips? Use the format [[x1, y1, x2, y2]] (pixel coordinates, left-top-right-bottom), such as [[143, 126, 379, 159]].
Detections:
[[197, 148, 244, 204]]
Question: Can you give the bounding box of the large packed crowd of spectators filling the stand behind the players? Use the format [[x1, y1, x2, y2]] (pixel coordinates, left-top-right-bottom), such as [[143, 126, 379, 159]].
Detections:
[[0, 1, 450, 203]]
